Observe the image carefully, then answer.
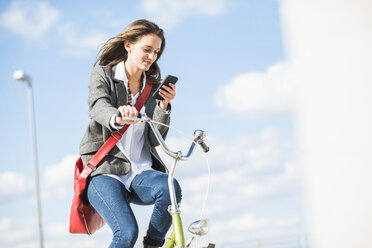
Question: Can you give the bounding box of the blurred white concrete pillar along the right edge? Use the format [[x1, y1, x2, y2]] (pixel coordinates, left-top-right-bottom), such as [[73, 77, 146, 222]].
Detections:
[[280, 0, 372, 248]]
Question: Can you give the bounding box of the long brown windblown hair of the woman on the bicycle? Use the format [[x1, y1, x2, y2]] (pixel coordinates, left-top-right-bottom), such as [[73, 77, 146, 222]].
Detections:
[[94, 19, 165, 83]]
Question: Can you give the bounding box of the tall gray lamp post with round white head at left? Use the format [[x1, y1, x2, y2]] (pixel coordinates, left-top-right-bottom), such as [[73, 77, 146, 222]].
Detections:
[[13, 70, 44, 248]]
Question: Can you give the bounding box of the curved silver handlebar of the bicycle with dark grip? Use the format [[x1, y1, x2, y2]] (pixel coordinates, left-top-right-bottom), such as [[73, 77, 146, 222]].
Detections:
[[118, 114, 209, 160]]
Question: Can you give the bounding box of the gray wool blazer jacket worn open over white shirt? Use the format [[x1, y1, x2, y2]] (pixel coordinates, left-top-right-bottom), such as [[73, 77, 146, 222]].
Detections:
[[80, 65, 170, 176]]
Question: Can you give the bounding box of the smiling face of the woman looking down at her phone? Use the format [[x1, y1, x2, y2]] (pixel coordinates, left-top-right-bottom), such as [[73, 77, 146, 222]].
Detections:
[[125, 34, 161, 71]]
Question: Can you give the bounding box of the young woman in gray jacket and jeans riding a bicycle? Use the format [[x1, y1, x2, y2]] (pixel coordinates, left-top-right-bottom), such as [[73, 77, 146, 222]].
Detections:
[[80, 20, 181, 248]]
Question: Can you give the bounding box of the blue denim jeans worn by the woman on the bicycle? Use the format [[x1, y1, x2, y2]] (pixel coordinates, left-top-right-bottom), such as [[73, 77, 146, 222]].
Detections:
[[87, 170, 181, 248]]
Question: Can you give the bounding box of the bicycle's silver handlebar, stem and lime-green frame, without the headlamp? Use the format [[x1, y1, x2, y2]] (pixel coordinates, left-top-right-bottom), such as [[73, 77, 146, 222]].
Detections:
[[123, 114, 209, 248]]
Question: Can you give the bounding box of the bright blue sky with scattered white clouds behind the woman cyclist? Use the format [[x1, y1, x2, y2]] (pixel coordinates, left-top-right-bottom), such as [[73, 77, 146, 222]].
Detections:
[[0, 0, 304, 247]]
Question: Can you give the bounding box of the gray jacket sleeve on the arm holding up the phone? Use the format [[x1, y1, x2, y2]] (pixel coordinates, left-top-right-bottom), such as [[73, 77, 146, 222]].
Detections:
[[149, 100, 171, 147]]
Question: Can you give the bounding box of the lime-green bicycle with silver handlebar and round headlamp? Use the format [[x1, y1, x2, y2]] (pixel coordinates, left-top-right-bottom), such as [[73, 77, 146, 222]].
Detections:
[[123, 114, 215, 248]]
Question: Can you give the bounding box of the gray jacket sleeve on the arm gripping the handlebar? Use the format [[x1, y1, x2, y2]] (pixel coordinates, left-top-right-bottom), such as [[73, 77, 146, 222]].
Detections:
[[88, 66, 117, 131]]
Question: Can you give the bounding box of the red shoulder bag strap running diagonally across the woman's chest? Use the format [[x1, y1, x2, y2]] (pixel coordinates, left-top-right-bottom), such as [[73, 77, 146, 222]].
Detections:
[[87, 83, 152, 172]]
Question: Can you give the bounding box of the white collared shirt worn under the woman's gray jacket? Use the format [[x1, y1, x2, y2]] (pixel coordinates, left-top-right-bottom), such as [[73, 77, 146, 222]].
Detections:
[[105, 62, 152, 191]]
